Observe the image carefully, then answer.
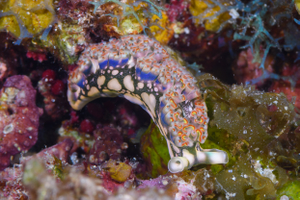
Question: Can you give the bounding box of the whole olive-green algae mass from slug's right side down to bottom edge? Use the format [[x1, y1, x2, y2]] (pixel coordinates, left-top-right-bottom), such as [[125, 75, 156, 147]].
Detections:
[[196, 74, 300, 200]]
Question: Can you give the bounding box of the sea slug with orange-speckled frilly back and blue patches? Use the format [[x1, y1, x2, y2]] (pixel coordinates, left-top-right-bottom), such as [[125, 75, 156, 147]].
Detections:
[[68, 35, 228, 173]]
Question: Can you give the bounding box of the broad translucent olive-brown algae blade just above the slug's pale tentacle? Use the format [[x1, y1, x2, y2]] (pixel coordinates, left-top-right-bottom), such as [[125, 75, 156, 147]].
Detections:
[[197, 74, 295, 163]]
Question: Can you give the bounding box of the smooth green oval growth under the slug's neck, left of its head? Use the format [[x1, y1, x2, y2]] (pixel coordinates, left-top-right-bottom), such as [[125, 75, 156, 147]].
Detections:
[[140, 121, 170, 178]]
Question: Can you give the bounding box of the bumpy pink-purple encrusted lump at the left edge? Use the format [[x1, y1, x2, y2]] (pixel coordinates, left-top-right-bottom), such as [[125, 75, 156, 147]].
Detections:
[[0, 75, 43, 170]]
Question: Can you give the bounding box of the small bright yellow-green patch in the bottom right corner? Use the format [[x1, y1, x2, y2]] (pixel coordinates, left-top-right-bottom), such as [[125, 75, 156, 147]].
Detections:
[[276, 180, 300, 200]]
